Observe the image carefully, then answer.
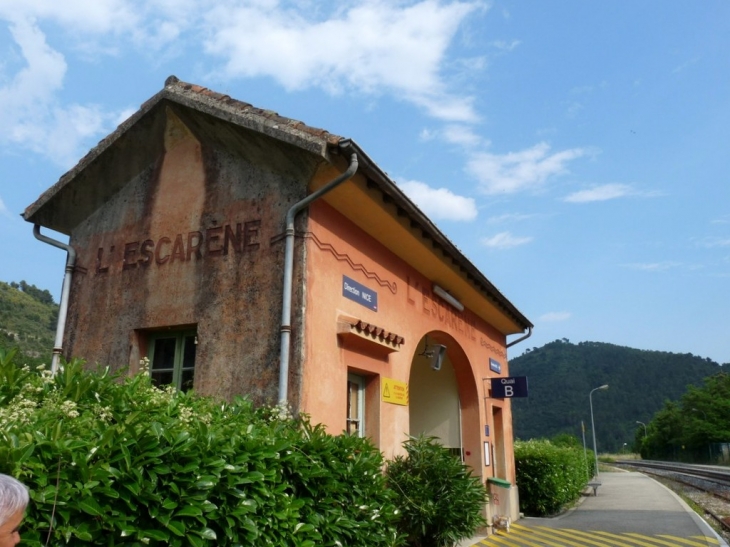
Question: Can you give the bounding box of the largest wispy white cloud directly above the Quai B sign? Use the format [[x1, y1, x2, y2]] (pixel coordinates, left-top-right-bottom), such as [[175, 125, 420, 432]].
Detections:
[[466, 142, 587, 194]]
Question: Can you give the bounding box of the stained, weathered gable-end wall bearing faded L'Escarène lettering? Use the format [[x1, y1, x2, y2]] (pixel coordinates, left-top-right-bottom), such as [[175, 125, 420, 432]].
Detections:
[[64, 107, 322, 402]]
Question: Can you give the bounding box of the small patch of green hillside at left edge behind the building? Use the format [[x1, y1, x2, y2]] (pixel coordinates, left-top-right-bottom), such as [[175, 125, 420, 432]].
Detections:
[[0, 281, 58, 365]]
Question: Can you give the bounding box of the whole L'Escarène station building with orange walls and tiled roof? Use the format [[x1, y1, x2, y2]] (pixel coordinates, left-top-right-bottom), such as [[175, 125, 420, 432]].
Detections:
[[23, 77, 532, 518]]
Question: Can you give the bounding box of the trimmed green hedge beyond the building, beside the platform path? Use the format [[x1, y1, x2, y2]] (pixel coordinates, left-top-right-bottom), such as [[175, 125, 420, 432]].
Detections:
[[515, 440, 595, 517]]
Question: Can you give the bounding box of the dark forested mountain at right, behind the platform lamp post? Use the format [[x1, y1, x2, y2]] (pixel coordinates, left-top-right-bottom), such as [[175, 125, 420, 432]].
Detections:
[[510, 339, 722, 453]]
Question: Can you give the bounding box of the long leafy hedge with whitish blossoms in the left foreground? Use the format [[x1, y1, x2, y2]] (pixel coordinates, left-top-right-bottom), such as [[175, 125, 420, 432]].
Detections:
[[0, 350, 400, 547]]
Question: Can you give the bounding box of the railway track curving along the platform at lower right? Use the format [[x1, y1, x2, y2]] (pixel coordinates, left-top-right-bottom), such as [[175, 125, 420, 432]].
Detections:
[[616, 460, 730, 540]]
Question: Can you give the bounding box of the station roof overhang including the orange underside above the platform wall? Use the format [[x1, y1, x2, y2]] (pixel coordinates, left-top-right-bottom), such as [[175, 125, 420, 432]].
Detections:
[[23, 76, 532, 336]]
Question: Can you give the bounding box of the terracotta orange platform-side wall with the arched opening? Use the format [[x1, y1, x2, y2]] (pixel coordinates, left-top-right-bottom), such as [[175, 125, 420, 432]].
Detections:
[[301, 201, 514, 480]]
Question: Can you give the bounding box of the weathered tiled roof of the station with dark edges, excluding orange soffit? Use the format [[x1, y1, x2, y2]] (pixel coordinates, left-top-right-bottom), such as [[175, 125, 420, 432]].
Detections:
[[23, 76, 532, 329]]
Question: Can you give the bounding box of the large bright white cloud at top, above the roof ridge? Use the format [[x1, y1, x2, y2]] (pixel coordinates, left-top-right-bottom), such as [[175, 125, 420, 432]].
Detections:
[[204, 0, 482, 121]]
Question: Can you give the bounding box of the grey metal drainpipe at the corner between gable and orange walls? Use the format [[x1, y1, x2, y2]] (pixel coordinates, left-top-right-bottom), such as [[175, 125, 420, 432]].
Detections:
[[279, 139, 357, 405]]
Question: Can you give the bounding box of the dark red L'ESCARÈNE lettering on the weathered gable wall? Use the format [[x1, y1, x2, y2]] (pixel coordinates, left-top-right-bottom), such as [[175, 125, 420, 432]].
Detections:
[[96, 219, 261, 274]]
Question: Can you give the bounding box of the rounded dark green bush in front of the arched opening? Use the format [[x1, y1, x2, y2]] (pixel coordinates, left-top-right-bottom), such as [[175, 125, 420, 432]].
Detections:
[[386, 436, 488, 547]]
